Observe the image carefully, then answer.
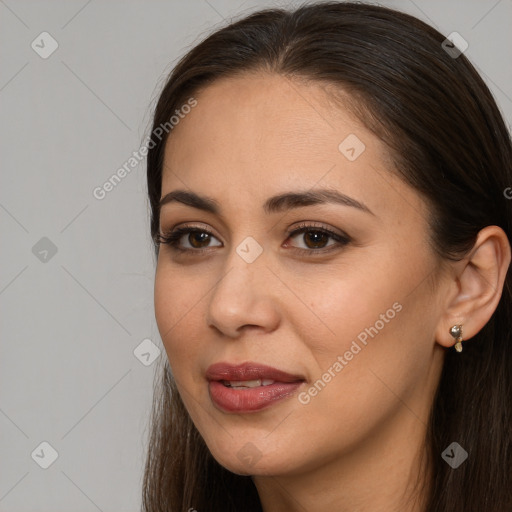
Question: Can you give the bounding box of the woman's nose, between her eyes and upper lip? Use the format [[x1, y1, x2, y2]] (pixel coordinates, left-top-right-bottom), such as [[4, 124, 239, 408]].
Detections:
[[206, 248, 280, 339]]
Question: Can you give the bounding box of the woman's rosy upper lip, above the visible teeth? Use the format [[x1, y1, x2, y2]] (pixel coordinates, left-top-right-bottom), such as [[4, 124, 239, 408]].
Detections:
[[206, 361, 305, 382]]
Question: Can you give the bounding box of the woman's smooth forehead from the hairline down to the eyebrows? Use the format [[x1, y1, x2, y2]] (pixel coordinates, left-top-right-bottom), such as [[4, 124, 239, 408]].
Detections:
[[162, 73, 428, 224]]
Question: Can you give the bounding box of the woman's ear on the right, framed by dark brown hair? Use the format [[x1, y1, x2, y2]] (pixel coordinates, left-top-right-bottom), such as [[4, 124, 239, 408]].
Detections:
[[436, 226, 511, 347]]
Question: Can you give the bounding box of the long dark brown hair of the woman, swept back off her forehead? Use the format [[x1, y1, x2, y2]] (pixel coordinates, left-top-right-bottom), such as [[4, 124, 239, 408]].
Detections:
[[143, 2, 512, 512]]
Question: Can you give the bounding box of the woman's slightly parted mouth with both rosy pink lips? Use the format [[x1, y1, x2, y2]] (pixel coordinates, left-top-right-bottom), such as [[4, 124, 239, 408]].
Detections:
[[206, 362, 305, 413]]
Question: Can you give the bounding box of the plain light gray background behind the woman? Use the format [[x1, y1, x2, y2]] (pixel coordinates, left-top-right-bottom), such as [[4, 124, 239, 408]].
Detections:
[[0, 0, 512, 512]]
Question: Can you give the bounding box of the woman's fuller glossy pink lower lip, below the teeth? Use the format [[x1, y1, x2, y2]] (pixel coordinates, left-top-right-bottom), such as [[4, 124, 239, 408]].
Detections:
[[209, 380, 302, 412]]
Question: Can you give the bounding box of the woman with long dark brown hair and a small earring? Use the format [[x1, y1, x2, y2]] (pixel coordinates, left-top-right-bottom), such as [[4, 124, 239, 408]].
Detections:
[[144, 2, 512, 512]]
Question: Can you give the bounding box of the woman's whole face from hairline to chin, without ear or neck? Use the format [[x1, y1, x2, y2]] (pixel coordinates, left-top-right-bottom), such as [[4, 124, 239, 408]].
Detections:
[[155, 74, 448, 475]]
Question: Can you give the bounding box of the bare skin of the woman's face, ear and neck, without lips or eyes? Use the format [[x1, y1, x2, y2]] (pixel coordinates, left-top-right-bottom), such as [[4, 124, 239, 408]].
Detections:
[[155, 73, 510, 512]]
